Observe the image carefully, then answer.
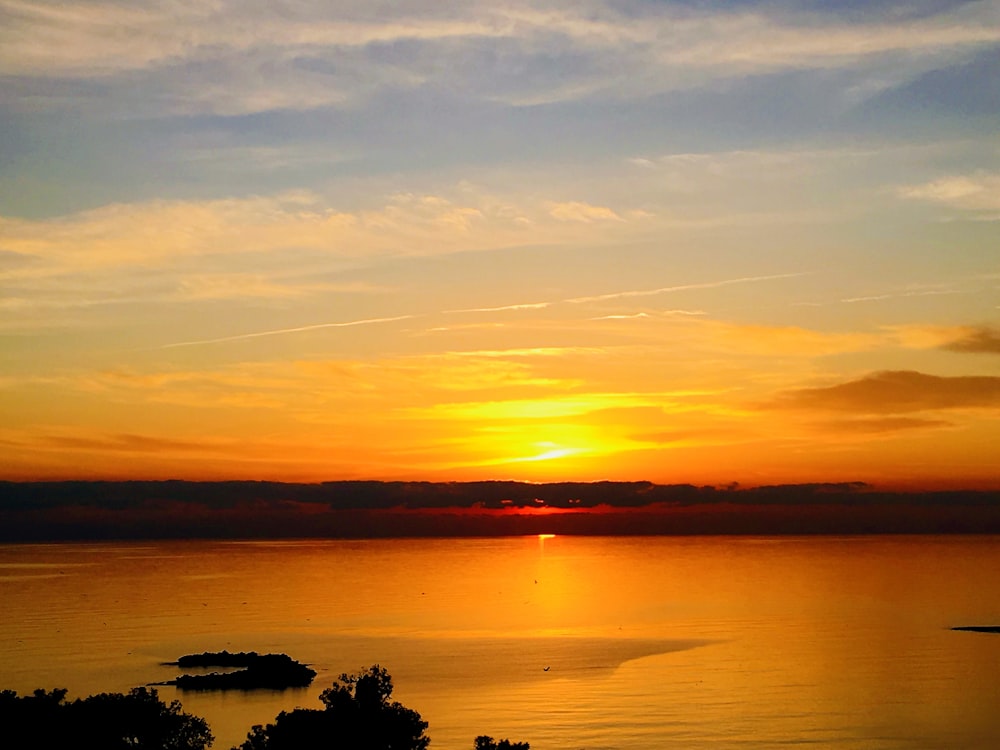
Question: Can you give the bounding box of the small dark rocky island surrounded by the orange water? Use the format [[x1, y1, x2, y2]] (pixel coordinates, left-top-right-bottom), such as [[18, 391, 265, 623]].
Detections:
[[159, 651, 316, 690]]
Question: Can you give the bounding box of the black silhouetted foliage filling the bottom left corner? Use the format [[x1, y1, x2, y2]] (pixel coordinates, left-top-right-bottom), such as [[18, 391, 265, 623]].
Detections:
[[0, 688, 213, 750]]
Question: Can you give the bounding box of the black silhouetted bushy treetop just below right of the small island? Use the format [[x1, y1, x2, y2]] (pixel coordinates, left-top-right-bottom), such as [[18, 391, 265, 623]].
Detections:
[[239, 664, 430, 750]]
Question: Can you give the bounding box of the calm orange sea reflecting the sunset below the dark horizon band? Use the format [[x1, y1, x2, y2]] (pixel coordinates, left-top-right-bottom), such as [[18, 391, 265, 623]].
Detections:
[[0, 536, 1000, 750]]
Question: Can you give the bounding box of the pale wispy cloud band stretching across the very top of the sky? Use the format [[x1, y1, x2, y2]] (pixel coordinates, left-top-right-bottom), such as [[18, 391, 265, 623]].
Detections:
[[0, 0, 1000, 114]]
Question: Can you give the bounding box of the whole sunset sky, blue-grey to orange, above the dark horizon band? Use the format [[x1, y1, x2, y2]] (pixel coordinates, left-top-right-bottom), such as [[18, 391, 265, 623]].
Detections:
[[0, 0, 1000, 488]]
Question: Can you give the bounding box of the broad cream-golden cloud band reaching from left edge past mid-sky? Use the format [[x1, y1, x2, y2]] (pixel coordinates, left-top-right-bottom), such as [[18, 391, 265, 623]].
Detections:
[[0, 186, 648, 325]]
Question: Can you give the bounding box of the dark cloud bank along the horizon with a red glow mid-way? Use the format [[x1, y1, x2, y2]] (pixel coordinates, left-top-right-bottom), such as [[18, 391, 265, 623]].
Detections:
[[0, 480, 1000, 542]]
